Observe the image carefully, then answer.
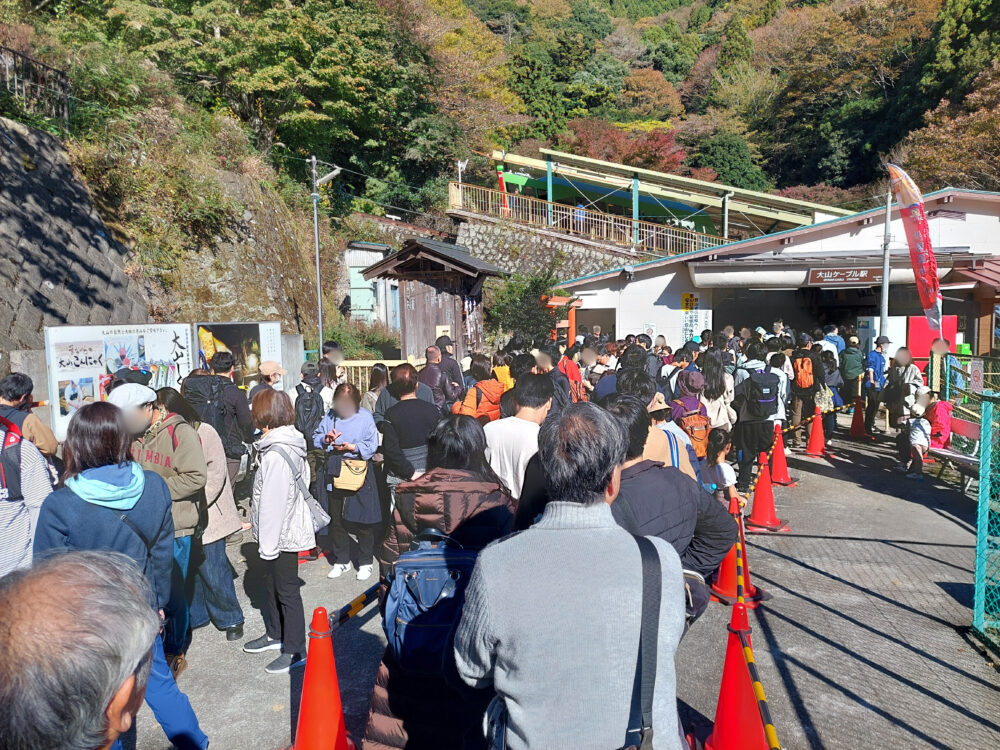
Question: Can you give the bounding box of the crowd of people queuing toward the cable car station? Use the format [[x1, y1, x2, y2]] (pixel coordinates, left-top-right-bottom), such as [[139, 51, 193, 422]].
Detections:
[[0, 321, 964, 750]]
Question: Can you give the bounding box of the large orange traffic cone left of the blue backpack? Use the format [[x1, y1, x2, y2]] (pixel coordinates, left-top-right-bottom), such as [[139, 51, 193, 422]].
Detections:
[[291, 607, 354, 750]]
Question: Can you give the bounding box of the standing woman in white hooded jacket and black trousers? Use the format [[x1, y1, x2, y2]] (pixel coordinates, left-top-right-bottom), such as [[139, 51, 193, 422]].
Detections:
[[243, 391, 316, 674]]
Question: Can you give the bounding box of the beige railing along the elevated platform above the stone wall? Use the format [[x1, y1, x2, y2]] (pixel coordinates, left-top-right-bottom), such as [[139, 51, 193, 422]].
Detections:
[[448, 182, 727, 256]]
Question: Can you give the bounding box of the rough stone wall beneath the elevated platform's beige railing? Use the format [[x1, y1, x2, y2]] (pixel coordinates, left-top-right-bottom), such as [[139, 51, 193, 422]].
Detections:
[[457, 218, 637, 279]]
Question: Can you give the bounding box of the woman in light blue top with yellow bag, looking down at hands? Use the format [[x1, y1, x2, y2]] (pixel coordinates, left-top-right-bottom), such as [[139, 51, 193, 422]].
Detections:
[[313, 383, 384, 581]]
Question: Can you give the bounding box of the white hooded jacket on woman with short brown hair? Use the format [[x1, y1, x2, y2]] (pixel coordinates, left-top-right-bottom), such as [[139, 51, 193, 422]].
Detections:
[[250, 425, 316, 560]]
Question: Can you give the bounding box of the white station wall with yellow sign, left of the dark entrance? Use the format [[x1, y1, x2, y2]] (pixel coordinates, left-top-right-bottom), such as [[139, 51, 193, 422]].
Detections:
[[569, 265, 712, 349]]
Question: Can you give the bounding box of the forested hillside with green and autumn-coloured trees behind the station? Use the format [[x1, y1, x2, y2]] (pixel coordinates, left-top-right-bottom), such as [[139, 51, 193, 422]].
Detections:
[[0, 0, 1000, 269]]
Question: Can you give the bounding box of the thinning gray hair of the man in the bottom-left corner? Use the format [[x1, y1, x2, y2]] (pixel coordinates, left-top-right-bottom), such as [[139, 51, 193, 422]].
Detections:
[[0, 551, 160, 750]]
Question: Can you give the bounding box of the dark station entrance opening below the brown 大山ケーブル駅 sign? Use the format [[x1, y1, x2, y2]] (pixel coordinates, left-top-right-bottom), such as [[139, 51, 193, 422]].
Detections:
[[712, 287, 879, 333]]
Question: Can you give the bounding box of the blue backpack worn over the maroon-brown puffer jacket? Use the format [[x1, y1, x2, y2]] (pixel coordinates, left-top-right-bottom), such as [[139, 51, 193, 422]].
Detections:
[[382, 529, 478, 674]]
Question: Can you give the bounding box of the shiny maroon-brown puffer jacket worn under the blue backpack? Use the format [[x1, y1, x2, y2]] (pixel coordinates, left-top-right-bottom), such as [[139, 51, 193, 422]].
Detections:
[[362, 469, 514, 750]]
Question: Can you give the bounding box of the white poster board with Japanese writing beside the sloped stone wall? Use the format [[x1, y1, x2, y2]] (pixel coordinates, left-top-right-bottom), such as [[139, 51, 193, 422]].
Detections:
[[45, 323, 195, 440]]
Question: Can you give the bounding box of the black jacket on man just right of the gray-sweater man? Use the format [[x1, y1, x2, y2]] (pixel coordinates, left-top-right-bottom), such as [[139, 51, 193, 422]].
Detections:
[[611, 461, 737, 576]]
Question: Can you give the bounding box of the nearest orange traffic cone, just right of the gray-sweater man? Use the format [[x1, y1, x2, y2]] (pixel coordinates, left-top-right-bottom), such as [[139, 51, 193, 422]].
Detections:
[[705, 604, 767, 750]]
